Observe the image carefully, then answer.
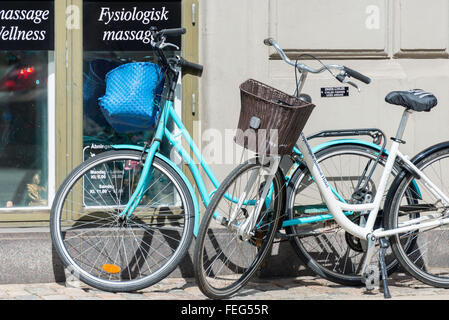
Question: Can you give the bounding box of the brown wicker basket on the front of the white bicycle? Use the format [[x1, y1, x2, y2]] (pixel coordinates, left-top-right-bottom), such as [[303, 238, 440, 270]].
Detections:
[[234, 79, 315, 155]]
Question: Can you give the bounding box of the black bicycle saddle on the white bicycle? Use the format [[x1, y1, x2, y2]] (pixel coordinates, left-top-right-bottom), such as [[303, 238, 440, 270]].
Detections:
[[385, 89, 438, 112]]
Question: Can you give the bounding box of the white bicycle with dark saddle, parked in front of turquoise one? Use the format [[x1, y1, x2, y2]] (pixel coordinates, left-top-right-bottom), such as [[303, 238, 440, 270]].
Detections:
[[194, 39, 449, 298]]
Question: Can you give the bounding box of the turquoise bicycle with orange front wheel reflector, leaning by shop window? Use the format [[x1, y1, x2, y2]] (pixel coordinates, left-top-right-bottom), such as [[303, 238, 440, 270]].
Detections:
[[50, 29, 416, 292]]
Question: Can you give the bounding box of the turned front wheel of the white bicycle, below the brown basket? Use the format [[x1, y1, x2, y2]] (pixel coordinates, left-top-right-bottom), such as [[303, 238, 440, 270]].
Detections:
[[194, 160, 285, 299]]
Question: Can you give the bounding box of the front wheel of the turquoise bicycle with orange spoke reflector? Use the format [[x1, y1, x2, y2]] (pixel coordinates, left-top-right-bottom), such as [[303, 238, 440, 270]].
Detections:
[[50, 151, 194, 292]]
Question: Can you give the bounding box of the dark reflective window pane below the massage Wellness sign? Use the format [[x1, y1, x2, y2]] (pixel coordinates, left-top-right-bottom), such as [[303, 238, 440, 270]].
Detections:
[[0, 51, 49, 208]]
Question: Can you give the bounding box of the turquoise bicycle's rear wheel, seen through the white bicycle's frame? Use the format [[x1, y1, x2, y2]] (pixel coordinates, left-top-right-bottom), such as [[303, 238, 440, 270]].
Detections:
[[286, 144, 413, 286]]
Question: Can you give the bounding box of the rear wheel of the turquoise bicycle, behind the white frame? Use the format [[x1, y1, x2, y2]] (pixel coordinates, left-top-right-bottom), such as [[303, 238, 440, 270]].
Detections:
[[285, 144, 414, 286]]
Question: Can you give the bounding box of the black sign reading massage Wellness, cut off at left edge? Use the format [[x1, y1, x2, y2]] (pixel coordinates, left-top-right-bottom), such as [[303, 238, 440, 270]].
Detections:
[[0, 1, 55, 50]]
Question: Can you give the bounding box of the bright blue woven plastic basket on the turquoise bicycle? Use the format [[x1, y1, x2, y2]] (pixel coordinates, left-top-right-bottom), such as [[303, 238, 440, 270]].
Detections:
[[98, 62, 165, 133]]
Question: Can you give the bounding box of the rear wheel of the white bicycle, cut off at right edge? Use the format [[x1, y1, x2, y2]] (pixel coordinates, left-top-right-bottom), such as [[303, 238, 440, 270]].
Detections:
[[385, 148, 449, 288]]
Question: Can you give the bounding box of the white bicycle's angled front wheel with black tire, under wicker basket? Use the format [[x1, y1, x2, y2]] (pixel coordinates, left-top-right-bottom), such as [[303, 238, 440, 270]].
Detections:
[[194, 161, 285, 299]]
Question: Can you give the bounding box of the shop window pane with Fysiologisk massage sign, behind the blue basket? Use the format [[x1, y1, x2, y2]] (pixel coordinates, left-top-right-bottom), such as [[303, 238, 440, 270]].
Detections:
[[83, 0, 181, 205]]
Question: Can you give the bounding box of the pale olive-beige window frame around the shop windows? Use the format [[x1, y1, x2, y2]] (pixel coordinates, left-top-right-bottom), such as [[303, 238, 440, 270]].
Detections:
[[0, 0, 198, 227]]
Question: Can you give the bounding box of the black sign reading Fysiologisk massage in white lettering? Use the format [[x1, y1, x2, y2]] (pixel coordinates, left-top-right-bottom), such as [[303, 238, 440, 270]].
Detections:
[[83, 0, 181, 51]]
